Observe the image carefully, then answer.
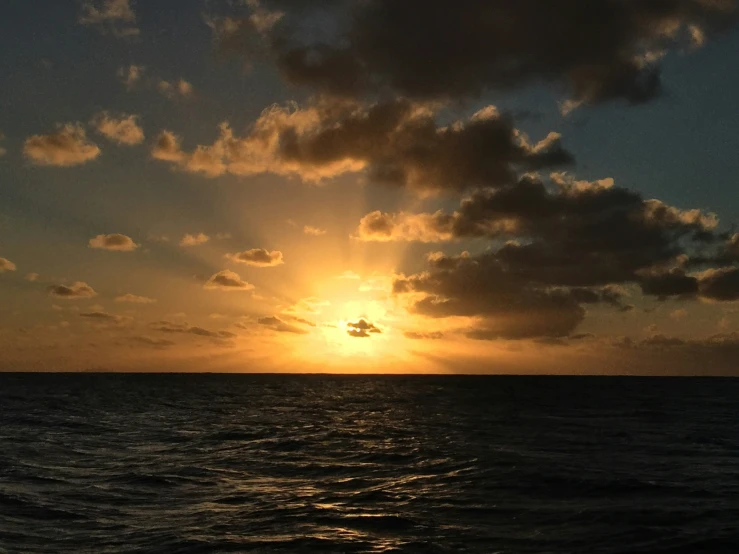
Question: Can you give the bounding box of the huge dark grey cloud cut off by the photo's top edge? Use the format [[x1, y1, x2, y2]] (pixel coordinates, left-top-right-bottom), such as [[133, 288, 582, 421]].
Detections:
[[258, 0, 736, 105]]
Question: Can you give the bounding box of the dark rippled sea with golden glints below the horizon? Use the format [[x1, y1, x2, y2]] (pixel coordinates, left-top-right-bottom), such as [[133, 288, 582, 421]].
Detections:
[[0, 375, 739, 554]]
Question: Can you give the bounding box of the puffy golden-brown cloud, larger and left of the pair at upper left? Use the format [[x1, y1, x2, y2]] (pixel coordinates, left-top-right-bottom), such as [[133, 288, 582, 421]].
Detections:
[[23, 123, 100, 167]]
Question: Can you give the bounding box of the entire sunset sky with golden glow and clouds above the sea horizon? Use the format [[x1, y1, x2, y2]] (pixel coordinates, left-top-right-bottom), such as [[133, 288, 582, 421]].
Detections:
[[0, 0, 739, 375]]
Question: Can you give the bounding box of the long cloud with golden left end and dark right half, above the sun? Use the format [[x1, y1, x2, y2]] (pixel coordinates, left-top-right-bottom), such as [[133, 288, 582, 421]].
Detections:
[[152, 99, 573, 193]]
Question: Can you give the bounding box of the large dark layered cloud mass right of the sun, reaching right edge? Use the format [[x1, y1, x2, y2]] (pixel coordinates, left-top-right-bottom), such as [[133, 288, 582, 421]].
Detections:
[[388, 174, 739, 339]]
